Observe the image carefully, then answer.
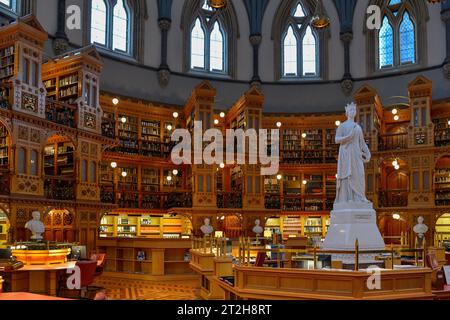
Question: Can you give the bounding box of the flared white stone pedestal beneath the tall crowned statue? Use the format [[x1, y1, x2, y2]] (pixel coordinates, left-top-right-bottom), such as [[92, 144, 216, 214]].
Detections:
[[322, 202, 385, 264]]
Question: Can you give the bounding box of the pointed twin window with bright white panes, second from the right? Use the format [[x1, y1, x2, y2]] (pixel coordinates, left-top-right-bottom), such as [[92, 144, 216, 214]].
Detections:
[[272, 0, 326, 78]]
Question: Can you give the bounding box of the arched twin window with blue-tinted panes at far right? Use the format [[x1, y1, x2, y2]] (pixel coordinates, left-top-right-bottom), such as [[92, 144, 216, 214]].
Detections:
[[368, 0, 428, 71]]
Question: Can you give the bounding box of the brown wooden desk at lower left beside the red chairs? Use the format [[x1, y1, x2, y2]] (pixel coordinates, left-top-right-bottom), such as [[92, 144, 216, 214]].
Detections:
[[2, 261, 76, 296]]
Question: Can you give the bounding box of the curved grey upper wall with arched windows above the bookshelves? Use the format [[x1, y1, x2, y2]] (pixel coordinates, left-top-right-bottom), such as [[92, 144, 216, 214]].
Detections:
[[0, 0, 450, 113]]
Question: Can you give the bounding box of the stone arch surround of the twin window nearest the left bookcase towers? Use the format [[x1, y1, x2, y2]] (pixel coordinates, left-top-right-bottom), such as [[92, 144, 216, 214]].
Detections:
[[83, 0, 149, 62]]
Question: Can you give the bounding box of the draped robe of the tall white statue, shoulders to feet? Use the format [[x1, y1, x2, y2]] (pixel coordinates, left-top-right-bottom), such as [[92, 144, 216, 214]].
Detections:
[[335, 121, 370, 203]]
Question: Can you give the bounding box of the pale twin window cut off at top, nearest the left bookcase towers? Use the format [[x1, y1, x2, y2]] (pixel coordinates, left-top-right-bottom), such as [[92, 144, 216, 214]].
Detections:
[[90, 0, 132, 54]]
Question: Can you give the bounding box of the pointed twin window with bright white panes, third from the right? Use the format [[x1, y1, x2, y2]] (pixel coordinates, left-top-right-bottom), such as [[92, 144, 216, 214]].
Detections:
[[182, 0, 238, 75]]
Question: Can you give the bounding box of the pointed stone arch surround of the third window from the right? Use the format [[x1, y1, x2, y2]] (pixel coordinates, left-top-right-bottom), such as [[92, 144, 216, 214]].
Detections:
[[180, 0, 240, 78]]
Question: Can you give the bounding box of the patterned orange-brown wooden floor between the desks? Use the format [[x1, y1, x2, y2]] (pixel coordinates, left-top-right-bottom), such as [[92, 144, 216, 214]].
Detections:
[[94, 275, 199, 300]]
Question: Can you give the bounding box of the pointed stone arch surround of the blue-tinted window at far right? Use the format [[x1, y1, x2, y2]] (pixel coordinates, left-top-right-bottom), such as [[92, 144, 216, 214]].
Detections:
[[362, 0, 430, 73]]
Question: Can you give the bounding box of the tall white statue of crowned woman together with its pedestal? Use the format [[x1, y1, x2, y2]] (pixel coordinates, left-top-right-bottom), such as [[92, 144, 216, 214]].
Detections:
[[323, 103, 385, 263]]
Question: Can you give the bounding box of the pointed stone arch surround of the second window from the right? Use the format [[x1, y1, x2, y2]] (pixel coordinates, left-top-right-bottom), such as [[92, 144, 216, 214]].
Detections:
[[271, 0, 331, 80]]
